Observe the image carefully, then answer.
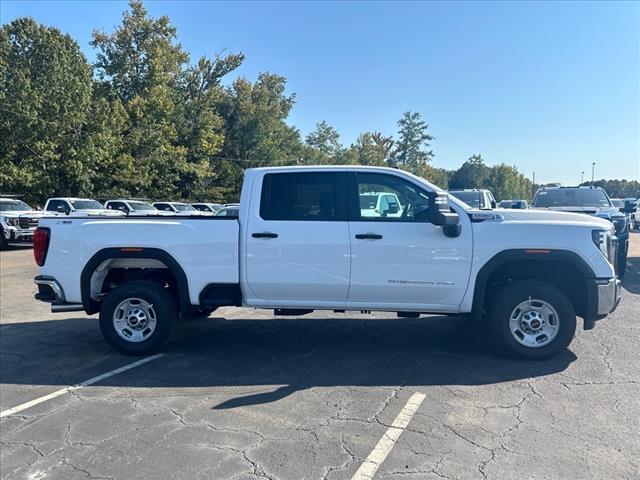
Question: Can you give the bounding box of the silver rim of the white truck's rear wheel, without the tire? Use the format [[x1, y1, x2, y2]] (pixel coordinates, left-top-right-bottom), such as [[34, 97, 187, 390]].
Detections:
[[113, 298, 157, 343]]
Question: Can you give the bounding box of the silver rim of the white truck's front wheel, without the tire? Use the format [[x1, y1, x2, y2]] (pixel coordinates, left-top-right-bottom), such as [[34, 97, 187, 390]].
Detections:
[[509, 299, 560, 348]]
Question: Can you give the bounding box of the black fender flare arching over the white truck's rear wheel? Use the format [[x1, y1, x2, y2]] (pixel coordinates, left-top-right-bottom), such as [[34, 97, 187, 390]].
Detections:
[[80, 247, 191, 315]]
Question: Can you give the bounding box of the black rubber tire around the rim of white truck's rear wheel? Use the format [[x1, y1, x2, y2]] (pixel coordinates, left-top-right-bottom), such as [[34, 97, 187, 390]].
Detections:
[[100, 280, 178, 355]]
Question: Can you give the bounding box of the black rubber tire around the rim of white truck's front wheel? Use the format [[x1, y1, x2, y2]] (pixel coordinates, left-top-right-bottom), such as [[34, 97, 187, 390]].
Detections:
[[487, 280, 576, 360]]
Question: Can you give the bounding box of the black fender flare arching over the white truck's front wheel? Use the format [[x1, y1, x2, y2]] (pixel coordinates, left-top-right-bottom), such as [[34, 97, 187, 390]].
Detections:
[[471, 248, 597, 321]]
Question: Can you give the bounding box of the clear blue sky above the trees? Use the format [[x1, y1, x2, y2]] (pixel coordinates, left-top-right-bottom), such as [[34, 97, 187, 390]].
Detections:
[[0, 1, 640, 184]]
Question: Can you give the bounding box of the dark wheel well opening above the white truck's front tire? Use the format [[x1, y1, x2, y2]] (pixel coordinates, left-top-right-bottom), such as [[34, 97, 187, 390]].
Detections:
[[482, 258, 588, 318]]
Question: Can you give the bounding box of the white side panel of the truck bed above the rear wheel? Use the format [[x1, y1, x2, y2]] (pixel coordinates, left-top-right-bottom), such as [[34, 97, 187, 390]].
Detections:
[[40, 216, 240, 305]]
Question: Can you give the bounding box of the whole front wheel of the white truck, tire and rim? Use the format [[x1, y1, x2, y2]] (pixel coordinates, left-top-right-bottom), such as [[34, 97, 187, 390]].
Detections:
[[488, 280, 576, 360]]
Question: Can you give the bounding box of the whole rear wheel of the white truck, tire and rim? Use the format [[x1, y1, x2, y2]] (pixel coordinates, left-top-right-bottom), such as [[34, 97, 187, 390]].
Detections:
[[100, 280, 177, 355]]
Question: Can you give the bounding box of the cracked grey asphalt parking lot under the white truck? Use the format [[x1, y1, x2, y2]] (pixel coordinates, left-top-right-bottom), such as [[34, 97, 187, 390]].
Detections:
[[0, 233, 640, 480]]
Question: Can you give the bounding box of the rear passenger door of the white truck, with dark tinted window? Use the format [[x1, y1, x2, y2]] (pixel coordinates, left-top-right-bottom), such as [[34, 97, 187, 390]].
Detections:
[[243, 171, 350, 307]]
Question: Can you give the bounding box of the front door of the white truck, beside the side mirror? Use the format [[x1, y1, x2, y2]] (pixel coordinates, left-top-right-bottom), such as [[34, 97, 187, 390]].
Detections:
[[348, 172, 472, 312]]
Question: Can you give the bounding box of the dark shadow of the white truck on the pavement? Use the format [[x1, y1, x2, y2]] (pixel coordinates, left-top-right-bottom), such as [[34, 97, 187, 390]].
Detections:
[[0, 314, 576, 409]]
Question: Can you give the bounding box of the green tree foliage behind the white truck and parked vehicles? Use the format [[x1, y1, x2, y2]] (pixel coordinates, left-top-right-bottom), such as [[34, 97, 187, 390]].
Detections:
[[0, 0, 544, 204]]
